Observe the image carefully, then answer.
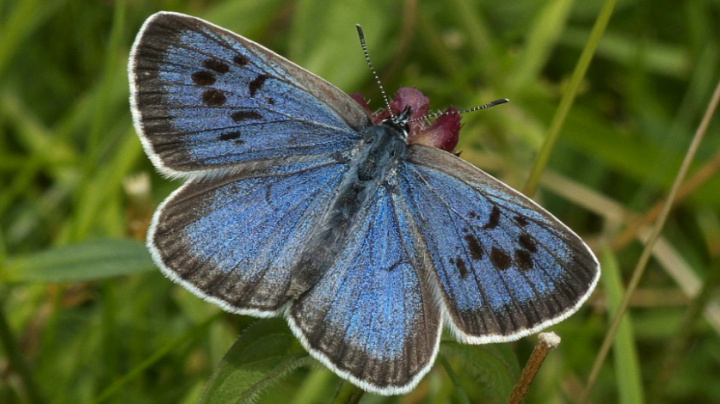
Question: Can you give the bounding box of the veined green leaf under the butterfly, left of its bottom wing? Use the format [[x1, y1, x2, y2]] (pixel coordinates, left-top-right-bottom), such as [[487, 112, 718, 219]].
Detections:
[[201, 318, 314, 403]]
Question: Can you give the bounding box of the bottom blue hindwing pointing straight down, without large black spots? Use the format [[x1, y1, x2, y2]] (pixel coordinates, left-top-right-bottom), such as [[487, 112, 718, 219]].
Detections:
[[287, 186, 441, 394]]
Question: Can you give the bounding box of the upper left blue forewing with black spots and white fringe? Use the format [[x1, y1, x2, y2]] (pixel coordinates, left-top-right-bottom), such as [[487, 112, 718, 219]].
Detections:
[[128, 12, 370, 177]]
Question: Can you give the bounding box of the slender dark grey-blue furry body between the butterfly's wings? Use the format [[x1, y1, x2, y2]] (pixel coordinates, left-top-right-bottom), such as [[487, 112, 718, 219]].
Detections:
[[287, 118, 407, 298]]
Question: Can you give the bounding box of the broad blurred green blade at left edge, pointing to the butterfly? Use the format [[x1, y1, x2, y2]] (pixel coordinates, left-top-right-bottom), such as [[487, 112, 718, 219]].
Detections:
[[0, 239, 155, 283]]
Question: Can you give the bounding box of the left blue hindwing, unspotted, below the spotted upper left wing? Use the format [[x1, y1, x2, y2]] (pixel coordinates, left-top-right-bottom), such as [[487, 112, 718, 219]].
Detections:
[[148, 155, 347, 316]]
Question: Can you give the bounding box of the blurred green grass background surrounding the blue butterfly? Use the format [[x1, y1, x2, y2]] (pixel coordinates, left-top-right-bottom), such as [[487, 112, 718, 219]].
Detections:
[[0, 0, 720, 403]]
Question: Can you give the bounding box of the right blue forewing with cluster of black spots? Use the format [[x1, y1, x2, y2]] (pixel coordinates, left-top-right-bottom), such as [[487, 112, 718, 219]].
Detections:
[[397, 145, 600, 343]]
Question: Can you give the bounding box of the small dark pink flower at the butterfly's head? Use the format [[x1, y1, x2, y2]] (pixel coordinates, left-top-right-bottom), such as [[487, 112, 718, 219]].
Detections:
[[350, 87, 461, 153]]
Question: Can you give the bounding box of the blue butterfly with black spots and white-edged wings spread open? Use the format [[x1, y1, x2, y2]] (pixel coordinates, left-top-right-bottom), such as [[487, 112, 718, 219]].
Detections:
[[128, 12, 600, 395]]
